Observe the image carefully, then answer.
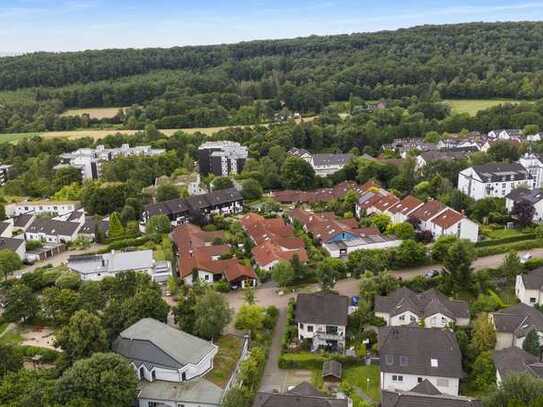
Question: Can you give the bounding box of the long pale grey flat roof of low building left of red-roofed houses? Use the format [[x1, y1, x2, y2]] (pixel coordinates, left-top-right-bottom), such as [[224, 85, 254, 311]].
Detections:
[[68, 250, 155, 274]]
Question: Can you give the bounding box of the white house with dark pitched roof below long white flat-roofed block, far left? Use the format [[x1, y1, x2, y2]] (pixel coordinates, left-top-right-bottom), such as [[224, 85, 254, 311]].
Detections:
[[24, 218, 81, 243]]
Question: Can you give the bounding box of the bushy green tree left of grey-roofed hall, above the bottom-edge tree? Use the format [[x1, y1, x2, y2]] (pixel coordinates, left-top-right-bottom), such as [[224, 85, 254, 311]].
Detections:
[[55, 310, 108, 363]]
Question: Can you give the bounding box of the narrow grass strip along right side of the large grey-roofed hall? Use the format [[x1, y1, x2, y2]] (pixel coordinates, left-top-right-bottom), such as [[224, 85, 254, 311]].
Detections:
[[206, 335, 243, 388]]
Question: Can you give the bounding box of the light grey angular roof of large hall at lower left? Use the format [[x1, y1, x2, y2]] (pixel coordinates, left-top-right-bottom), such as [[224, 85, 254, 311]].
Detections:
[[113, 318, 217, 368]]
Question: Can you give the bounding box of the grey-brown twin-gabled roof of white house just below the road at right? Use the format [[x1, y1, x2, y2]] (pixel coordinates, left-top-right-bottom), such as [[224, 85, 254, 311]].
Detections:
[[375, 287, 469, 319]]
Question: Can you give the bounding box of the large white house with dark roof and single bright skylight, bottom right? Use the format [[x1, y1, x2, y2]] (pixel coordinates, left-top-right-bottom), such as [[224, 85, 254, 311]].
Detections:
[[378, 326, 464, 396]]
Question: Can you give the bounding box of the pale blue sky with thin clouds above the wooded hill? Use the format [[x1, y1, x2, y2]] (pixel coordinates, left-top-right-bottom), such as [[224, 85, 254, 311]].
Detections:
[[0, 0, 543, 54]]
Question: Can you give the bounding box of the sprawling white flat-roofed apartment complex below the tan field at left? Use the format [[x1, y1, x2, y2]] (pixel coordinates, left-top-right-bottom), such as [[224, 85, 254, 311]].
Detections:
[[55, 144, 166, 180]]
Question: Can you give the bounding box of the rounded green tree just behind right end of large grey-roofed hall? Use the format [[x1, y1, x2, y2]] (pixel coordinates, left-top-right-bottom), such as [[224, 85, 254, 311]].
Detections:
[[194, 289, 232, 339]]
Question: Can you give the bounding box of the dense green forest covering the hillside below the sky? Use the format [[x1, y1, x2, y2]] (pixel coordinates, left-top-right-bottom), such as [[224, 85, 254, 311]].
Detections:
[[0, 22, 543, 132]]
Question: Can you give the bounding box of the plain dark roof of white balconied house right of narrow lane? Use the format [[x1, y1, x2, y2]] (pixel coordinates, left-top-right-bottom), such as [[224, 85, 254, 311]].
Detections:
[[296, 293, 349, 326]]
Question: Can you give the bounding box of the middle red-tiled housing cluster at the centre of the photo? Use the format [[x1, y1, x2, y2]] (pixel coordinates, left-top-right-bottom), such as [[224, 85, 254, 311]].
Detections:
[[240, 213, 308, 270]]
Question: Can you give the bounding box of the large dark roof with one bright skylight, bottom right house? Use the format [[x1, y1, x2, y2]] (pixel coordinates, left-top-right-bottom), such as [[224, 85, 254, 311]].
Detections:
[[378, 326, 464, 378]]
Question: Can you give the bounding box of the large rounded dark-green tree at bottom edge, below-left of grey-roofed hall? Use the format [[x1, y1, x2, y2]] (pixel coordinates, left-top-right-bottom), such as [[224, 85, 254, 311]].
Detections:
[[55, 353, 138, 407]]
